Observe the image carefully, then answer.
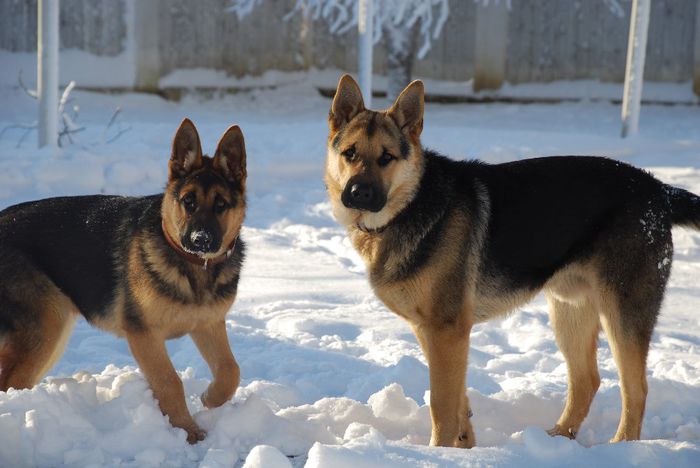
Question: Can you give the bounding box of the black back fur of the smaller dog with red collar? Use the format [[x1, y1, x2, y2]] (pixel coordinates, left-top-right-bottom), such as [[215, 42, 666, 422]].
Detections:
[[0, 195, 157, 319]]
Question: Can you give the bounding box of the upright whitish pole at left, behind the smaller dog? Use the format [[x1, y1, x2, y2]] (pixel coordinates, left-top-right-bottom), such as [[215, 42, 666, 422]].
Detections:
[[37, 0, 59, 147]]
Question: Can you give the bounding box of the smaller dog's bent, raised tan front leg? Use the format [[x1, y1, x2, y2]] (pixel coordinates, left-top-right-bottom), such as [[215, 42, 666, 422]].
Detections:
[[190, 320, 241, 408]]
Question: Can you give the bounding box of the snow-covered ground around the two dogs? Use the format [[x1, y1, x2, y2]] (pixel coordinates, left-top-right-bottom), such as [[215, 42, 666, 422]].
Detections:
[[0, 78, 700, 468]]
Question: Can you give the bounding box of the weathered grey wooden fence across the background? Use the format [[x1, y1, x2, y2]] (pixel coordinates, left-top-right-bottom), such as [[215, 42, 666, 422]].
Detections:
[[0, 0, 700, 94]]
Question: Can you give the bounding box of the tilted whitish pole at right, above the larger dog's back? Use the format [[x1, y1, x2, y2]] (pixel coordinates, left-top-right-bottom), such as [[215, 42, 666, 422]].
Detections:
[[622, 0, 651, 138]]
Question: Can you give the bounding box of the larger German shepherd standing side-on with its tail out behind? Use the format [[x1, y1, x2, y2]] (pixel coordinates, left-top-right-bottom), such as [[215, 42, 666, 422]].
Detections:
[[325, 75, 700, 447]]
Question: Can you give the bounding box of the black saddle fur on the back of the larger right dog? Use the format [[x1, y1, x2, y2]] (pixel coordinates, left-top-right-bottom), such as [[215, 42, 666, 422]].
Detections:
[[476, 156, 668, 288]]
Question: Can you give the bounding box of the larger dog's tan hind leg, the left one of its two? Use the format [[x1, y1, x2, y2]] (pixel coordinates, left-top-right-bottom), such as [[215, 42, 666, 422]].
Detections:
[[547, 295, 600, 439]]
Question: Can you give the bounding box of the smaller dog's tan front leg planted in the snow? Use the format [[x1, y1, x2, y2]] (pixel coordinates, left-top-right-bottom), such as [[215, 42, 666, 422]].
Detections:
[[127, 331, 206, 444]]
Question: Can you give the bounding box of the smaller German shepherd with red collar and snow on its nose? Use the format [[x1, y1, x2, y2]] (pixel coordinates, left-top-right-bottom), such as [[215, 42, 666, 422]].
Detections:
[[0, 119, 246, 443]]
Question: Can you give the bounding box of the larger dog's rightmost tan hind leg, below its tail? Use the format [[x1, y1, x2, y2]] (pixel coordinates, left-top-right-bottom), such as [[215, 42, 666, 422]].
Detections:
[[602, 307, 649, 442]]
